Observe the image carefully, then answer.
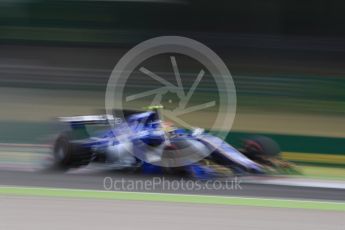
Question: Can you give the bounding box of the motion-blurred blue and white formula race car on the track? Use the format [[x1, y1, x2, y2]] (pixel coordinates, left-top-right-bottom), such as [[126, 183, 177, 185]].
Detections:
[[53, 106, 293, 178]]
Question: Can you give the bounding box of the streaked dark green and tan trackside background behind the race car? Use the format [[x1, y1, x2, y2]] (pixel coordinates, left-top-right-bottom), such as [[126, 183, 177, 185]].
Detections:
[[0, 0, 345, 178]]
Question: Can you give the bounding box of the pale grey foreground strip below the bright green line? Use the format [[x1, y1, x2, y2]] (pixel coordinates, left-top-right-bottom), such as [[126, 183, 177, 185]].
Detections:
[[0, 196, 344, 230]]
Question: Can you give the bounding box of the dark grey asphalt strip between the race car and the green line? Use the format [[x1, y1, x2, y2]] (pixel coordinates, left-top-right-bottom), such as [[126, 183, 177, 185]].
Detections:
[[0, 171, 345, 201]]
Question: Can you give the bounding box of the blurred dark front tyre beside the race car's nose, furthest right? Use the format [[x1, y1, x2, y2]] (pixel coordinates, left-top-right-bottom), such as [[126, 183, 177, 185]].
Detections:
[[244, 136, 280, 157]]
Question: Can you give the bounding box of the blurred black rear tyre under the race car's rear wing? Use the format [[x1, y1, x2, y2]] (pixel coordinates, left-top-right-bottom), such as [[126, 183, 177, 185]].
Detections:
[[53, 132, 93, 170]]
